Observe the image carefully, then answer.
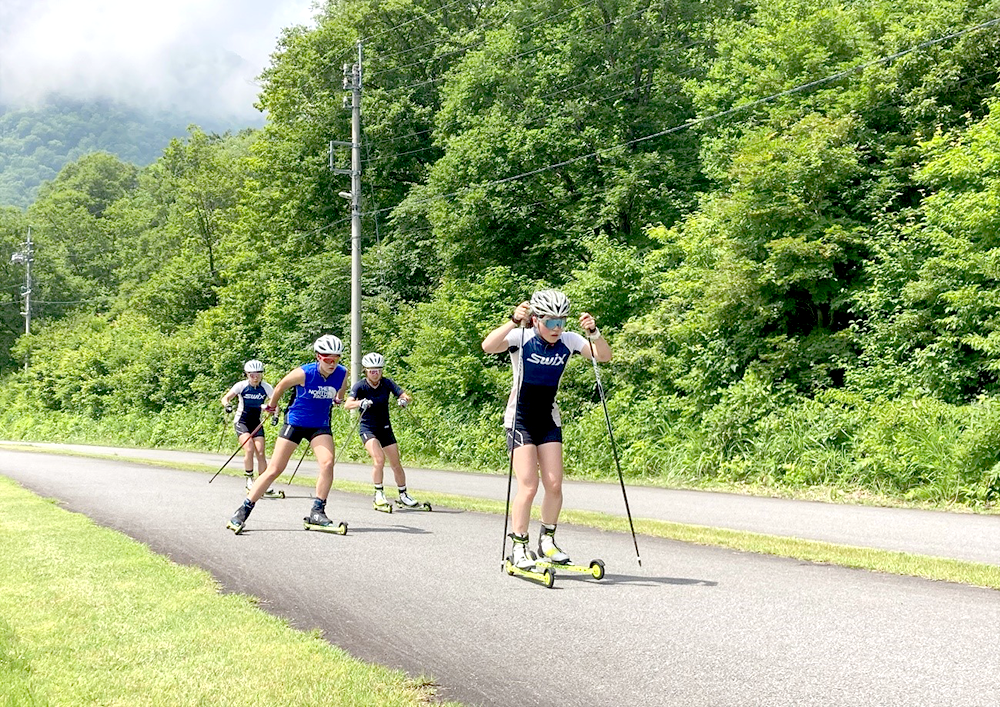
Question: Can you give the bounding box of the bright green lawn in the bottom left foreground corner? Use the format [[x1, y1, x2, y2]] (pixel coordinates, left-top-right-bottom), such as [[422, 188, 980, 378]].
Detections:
[[0, 477, 458, 707]]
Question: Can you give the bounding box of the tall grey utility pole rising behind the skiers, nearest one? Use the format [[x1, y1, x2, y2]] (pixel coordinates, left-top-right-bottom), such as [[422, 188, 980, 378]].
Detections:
[[330, 41, 363, 385]]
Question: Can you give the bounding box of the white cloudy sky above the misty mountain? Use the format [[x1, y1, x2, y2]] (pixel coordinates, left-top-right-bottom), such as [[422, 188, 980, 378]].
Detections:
[[0, 0, 314, 122]]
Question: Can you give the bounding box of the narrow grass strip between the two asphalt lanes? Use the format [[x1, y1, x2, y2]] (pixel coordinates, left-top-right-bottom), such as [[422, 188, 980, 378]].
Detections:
[[0, 445, 1000, 589]]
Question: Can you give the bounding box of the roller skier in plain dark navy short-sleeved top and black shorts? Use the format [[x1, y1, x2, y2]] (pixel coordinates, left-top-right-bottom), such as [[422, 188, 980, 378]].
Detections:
[[344, 353, 431, 513]]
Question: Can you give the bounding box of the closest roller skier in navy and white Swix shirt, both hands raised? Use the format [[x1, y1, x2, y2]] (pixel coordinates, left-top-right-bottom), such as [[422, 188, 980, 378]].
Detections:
[[482, 290, 611, 586]]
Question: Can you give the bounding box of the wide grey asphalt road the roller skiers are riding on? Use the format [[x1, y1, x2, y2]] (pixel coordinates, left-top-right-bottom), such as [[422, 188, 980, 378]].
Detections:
[[0, 451, 1000, 707]]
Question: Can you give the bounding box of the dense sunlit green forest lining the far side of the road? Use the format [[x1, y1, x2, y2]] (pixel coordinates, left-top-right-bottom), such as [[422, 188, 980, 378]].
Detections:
[[0, 0, 1000, 504]]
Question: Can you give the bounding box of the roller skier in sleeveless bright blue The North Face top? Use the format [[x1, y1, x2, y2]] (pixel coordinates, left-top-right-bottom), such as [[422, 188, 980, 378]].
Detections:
[[226, 334, 347, 535]]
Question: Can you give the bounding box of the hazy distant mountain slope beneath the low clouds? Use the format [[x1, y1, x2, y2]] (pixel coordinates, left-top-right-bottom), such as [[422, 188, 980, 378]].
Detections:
[[0, 100, 263, 208]]
